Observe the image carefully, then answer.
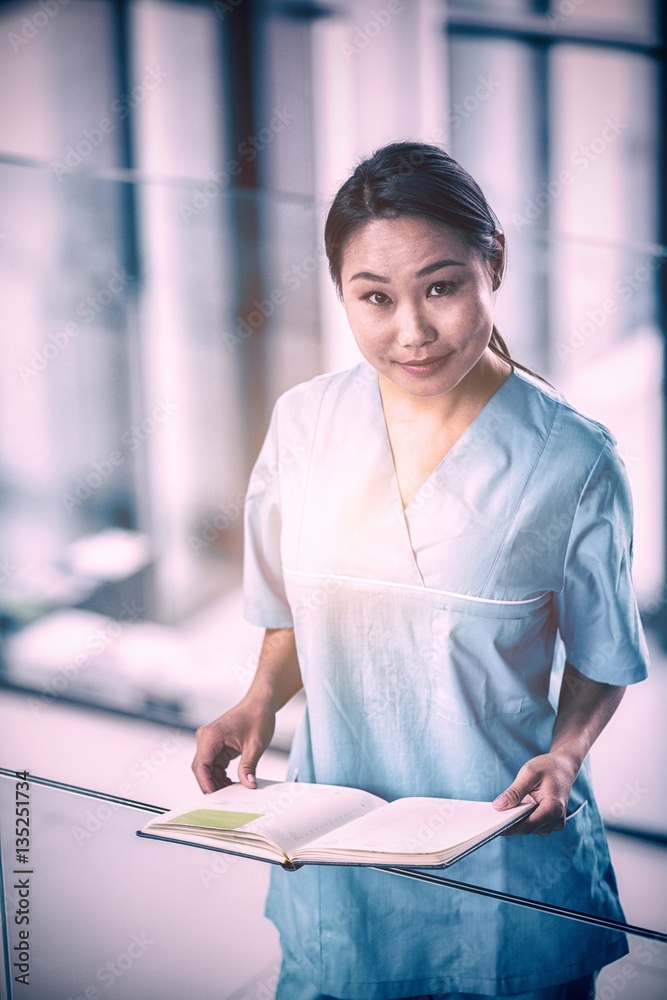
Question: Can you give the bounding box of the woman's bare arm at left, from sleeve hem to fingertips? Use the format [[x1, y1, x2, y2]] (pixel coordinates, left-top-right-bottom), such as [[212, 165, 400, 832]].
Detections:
[[192, 628, 302, 792]]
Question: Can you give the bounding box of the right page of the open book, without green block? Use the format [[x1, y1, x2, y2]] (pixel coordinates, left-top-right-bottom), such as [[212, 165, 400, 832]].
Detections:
[[310, 798, 533, 856]]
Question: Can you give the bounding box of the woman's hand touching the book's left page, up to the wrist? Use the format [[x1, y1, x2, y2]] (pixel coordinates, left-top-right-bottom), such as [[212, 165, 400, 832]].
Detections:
[[192, 697, 276, 793]]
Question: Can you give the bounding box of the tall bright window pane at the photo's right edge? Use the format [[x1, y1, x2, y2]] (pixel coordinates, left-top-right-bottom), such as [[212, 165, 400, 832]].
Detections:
[[548, 46, 664, 603]]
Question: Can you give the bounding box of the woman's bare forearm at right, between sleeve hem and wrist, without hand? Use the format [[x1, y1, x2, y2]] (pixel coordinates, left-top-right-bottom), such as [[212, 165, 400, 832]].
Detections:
[[550, 663, 625, 775]]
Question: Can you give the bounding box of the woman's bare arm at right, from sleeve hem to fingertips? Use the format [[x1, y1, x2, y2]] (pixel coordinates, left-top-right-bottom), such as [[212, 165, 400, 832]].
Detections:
[[493, 663, 625, 834]]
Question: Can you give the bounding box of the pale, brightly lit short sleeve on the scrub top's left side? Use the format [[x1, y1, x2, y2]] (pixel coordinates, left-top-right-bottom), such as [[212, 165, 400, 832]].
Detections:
[[243, 405, 294, 628]]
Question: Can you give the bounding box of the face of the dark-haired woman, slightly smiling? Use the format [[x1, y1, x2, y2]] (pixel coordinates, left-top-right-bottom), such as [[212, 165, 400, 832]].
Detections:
[[341, 216, 500, 396]]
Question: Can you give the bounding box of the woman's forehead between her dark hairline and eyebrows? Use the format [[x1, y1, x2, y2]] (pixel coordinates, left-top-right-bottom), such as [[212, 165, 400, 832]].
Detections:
[[342, 216, 475, 280]]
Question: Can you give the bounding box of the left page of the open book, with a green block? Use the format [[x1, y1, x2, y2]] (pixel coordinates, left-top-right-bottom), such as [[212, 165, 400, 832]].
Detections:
[[145, 779, 386, 856]]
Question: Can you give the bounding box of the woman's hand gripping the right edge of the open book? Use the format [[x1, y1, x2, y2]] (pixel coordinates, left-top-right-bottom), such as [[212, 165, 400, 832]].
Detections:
[[493, 752, 579, 836]]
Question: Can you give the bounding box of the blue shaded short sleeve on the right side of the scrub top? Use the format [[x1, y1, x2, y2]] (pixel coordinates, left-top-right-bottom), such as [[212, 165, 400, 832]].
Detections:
[[556, 440, 648, 685]]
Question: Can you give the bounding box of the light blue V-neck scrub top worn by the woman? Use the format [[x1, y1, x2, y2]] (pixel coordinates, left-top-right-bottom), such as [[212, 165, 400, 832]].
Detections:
[[244, 363, 647, 1000]]
